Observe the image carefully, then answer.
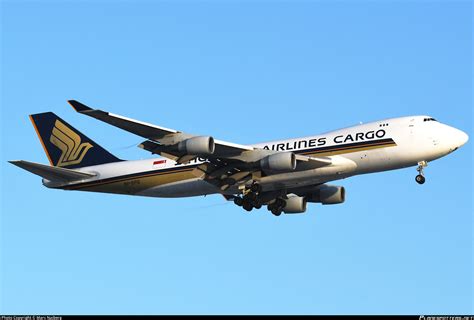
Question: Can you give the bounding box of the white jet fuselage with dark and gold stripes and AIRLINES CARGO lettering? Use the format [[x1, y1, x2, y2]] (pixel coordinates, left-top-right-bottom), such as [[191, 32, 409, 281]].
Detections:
[[50, 116, 468, 197]]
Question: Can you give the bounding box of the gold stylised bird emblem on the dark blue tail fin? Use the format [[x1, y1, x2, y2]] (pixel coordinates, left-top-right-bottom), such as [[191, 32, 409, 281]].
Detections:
[[49, 120, 93, 167]]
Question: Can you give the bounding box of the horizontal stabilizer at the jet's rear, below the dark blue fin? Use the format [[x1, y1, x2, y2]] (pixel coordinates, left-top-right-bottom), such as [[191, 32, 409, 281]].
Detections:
[[8, 160, 95, 182]]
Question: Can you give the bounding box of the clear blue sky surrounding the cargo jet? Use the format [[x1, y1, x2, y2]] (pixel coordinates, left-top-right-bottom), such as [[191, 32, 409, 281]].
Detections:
[[0, 1, 474, 314]]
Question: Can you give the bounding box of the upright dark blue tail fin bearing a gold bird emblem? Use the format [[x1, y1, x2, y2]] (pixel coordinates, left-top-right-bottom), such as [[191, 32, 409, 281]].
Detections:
[[30, 112, 122, 169]]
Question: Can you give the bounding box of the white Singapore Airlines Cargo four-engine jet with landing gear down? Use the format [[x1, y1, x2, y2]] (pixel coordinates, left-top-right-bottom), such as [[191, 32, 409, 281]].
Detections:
[[10, 100, 468, 216]]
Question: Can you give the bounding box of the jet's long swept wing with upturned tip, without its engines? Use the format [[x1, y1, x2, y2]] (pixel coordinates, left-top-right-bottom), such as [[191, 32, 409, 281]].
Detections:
[[68, 100, 332, 190]]
